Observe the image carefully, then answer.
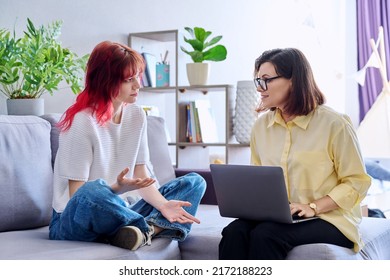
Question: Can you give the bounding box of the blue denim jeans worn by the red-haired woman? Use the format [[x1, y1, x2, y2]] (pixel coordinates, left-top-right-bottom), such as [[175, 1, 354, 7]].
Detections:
[[49, 173, 206, 241]]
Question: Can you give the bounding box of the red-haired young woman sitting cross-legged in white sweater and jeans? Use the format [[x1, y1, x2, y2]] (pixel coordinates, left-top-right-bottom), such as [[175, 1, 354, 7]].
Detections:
[[50, 41, 206, 250]]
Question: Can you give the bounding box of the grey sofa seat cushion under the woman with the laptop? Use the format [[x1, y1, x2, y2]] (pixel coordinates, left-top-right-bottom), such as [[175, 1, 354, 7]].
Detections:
[[179, 205, 390, 260]]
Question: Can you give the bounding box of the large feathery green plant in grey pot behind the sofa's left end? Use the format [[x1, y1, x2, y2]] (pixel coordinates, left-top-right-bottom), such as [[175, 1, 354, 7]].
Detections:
[[0, 19, 89, 115]]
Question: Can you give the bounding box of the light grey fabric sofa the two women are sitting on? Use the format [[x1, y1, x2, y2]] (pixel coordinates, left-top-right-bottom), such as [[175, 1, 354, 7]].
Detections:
[[0, 114, 390, 260]]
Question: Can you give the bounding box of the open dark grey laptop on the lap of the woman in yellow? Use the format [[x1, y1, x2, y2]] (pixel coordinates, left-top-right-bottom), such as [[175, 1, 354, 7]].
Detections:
[[210, 164, 317, 223]]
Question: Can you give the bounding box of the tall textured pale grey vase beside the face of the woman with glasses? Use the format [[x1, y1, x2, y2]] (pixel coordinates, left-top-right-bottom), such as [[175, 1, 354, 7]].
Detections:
[[233, 81, 260, 144]]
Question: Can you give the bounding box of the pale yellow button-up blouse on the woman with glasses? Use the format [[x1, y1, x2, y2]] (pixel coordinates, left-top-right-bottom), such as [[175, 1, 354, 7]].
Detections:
[[250, 105, 371, 251]]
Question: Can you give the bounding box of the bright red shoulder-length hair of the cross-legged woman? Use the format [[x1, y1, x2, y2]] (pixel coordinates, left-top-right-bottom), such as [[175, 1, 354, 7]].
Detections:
[[58, 41, 145, 131]]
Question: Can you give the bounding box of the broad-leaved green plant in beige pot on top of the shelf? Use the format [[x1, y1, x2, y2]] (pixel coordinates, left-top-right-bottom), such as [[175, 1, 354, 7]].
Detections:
[[180, 27, 227, 85]]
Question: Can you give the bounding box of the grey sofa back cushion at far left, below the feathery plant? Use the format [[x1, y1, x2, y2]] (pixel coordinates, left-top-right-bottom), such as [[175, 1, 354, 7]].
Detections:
[[0, 115, 53, 231]]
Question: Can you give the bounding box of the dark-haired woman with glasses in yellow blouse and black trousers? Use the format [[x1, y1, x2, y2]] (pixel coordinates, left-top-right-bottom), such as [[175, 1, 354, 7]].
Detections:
[[219, 48, 370, 260]]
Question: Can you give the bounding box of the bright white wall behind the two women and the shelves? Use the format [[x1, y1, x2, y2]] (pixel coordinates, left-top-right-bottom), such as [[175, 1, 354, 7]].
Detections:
[[0, 0, 357, 124]]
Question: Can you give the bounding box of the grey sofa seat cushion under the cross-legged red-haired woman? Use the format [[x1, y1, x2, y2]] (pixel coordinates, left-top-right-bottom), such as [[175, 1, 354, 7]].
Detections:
[[0, 226, 181, 260]]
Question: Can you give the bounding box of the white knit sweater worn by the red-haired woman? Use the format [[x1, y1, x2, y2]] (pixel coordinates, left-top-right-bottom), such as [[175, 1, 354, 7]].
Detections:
[[53, 104, 149, 213]]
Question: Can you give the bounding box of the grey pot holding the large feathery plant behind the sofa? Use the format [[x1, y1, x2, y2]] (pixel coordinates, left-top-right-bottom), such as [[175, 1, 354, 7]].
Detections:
[[7, 98, 45, 116]]
